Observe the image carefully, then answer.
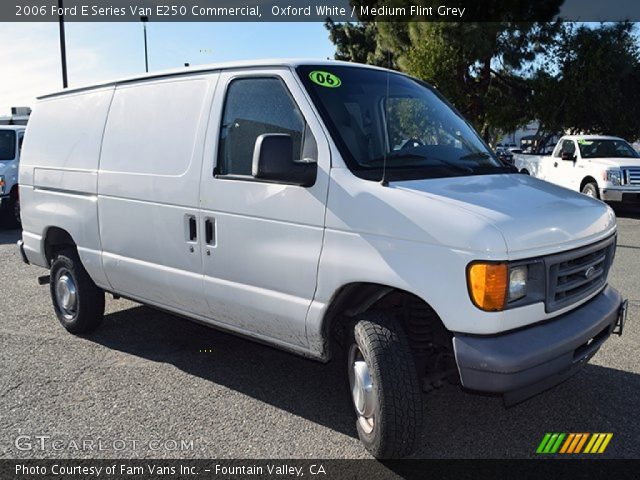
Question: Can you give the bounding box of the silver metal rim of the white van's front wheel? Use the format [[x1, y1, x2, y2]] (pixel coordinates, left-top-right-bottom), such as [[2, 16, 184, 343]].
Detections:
[[347, 344, 377, 433]]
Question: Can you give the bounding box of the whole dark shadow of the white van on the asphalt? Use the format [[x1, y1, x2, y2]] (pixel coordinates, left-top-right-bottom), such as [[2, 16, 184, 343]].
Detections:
[[88, 306, 640, 458]]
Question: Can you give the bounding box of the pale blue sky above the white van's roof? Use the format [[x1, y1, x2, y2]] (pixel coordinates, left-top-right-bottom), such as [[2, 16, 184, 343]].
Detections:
[[0, 22, 334, 115]]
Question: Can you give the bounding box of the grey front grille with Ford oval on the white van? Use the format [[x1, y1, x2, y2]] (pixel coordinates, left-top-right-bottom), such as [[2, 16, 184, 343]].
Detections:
[[545, 235, 616, 312]]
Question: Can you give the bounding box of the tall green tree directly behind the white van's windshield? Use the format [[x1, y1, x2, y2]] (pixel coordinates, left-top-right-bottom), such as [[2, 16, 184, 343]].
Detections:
[[330, 0, 562, 140]]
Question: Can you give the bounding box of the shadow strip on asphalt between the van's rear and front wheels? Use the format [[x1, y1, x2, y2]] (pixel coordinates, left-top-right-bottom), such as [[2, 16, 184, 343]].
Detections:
[[93, 306, 357, 436]]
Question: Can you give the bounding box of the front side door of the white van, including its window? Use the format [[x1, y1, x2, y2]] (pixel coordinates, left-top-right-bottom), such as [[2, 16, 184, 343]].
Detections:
[[200, 68, 330, 350]]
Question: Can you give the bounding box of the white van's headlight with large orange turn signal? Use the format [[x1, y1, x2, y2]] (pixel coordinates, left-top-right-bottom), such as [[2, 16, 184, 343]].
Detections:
[[467, 261, 544, 312]]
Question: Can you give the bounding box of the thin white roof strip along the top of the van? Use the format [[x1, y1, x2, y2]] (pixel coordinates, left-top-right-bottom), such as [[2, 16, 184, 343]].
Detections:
[[38, 58, 386, 100]]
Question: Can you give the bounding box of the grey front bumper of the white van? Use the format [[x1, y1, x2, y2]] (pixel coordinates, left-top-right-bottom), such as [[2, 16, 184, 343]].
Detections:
[[453, 286, 627, 405]]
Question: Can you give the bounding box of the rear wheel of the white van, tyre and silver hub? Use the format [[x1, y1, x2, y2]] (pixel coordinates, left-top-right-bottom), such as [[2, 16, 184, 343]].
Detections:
[[49, 249, 104, 334]]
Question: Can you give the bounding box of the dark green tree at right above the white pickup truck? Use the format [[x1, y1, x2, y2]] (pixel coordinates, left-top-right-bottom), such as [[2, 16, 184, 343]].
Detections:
[[532, 23, 640, 140]]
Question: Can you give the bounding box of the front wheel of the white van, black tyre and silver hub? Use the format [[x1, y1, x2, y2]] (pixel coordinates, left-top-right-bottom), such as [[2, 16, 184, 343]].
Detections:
[[346, 312, 422, 458]]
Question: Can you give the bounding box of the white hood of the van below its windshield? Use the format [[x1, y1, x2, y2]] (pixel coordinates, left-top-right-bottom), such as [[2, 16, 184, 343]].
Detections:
[[391, 174, 616, 256]]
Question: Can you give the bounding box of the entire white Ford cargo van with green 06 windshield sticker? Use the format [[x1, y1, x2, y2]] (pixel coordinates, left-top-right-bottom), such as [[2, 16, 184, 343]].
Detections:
[[19, 60, 626, 457]]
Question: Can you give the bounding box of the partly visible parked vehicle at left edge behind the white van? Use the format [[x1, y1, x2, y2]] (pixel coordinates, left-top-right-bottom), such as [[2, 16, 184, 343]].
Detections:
[[0, 125, 25, 226]]
